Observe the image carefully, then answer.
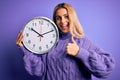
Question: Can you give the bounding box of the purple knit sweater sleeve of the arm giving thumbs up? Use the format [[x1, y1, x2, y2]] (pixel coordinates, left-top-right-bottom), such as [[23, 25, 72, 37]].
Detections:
[[76, 37, 115, 78]]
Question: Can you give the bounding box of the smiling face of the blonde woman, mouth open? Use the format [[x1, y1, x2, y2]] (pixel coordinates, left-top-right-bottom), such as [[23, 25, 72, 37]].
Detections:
[[56, 8, 69, 33]]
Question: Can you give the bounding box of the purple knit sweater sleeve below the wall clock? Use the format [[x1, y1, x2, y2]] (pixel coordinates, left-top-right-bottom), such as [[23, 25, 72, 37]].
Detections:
[[21, 47, 46, 76]]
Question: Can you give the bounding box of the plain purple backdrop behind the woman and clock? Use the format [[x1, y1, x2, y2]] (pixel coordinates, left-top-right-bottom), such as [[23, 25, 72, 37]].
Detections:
[[0, 0, 120, 80]]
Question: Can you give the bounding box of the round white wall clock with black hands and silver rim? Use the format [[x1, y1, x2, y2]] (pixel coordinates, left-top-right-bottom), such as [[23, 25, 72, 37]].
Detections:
[[23, 17, 59, 54]]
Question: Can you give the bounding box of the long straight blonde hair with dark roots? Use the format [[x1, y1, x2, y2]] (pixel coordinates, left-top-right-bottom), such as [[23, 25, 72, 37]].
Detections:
[[53, 3, 84, 38]]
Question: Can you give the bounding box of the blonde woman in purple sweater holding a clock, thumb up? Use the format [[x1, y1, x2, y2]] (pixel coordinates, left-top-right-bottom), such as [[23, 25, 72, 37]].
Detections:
[[16, 3, 114, 80]]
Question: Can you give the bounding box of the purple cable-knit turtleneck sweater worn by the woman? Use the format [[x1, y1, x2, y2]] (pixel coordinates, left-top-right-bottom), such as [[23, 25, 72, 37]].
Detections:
[[21, 33, 115, 80]]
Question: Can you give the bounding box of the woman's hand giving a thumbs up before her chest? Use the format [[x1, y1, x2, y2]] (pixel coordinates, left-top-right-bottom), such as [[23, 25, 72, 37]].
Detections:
[[66, 36, 80, 56]]
